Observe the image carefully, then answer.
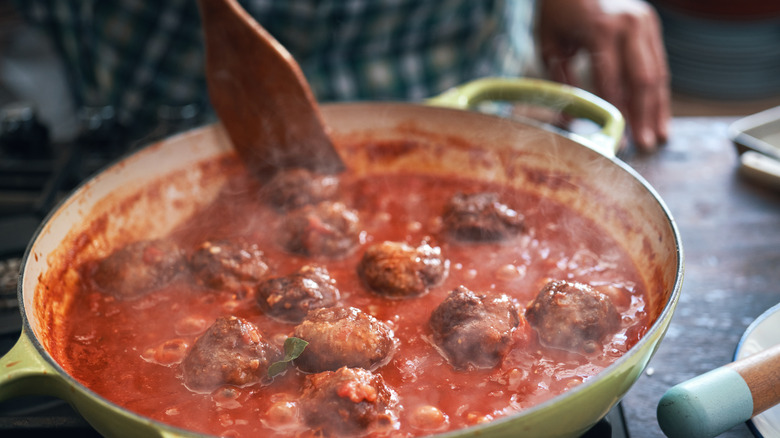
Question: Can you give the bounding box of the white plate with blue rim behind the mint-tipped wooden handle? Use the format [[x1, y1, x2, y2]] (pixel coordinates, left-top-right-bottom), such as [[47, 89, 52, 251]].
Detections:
[[734, 304, 780, 438]]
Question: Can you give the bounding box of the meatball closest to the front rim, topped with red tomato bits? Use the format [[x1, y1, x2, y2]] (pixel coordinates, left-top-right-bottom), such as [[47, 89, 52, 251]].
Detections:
[[301, 368, 400, 437]]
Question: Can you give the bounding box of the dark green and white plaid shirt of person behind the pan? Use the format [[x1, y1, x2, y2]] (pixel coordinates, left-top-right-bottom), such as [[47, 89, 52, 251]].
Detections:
[[17, 0, 532, 139]]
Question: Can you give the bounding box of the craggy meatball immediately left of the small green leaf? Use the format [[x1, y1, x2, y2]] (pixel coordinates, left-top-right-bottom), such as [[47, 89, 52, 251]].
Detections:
[[181, 316, 281, 391]]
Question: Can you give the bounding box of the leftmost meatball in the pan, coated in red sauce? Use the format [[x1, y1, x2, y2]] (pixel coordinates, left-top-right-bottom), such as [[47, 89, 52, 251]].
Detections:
[[92, 239, 186, 299]]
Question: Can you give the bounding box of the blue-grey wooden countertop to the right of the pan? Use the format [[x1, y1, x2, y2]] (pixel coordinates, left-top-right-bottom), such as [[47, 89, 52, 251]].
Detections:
[[621, 117, 780, 438]]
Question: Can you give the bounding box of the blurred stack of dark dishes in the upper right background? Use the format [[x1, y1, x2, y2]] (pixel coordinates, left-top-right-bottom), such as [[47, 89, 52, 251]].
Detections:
[[651, 0, 780, 116]]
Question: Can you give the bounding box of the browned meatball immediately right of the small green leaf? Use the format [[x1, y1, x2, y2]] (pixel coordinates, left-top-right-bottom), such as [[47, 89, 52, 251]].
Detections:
[[294, 307, 396, 373]]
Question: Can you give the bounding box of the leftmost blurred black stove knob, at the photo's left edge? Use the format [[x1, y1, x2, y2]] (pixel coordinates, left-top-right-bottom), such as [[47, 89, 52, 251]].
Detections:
[[0, 102, 52, 159]]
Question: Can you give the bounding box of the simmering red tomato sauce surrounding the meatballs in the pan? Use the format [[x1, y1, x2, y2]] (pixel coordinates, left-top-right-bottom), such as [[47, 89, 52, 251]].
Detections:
[[62, 162, 648, 437]]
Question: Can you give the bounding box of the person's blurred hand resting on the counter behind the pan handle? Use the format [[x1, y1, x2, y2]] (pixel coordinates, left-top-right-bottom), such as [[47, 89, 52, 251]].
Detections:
[[537, 0, 670, 150]]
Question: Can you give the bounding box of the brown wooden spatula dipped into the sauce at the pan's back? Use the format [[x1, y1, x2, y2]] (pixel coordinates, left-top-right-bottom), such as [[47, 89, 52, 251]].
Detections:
[[198, 0, 344, 178]]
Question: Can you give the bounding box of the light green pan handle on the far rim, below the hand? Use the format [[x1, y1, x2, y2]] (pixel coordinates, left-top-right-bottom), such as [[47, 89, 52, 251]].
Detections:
[[426, 78, 625, 157]]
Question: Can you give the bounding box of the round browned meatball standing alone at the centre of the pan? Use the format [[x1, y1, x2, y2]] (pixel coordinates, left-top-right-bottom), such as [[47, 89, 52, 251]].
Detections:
[[358, 242, 449, 298]]
